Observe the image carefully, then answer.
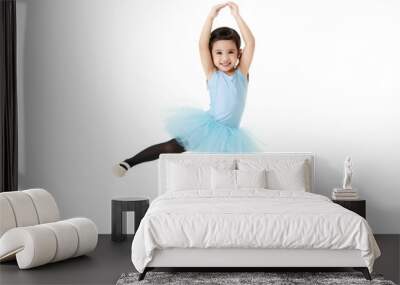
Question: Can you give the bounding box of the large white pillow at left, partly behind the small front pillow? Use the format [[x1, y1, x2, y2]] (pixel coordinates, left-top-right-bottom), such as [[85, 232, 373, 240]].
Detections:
[[166, 159, 235, 191]]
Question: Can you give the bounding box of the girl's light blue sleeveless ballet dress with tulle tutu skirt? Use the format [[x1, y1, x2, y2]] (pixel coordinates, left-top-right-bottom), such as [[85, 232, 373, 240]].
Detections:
[[165, 68, 263, 153]]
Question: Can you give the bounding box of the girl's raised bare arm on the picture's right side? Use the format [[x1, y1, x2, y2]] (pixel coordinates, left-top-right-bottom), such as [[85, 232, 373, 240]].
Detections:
[[227, 2, 255, 76]]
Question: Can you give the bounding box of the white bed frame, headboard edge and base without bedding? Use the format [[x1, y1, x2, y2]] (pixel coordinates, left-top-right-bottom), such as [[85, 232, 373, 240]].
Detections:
[[139, 152, 371, 280]]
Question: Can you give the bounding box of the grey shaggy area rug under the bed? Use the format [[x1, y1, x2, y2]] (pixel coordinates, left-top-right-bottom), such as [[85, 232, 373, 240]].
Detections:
[[116, 272, 395, 285]]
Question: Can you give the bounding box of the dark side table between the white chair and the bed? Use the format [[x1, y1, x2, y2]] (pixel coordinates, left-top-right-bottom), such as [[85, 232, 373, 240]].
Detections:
[[111, 197, 150, 241]]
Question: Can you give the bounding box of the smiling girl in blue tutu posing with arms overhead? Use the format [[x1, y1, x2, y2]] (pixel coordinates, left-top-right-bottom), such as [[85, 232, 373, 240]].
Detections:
[[113, 2, 262, 176]]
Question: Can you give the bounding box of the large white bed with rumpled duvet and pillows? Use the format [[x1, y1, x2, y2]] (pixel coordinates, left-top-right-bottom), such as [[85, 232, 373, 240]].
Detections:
[[132, 153, 380, 280]]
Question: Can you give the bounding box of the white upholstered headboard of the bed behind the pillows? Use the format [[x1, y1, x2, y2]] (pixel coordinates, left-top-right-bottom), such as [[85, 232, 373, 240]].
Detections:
[[158, 152, 315, 195]]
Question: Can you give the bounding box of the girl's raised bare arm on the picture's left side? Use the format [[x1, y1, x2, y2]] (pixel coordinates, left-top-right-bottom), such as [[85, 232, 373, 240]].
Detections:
[[199, 3, 228, 80]]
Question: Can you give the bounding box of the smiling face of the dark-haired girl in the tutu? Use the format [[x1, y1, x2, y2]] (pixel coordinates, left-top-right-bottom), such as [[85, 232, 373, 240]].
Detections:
[[212, 40, 239, 72]]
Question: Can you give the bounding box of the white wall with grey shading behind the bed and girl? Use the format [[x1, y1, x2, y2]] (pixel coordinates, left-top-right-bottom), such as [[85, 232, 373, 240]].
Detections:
[[17, 0, 400, 233]]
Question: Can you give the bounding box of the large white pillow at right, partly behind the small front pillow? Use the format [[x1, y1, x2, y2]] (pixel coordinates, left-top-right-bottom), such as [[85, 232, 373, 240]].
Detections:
[[238, 159, 311, 191]]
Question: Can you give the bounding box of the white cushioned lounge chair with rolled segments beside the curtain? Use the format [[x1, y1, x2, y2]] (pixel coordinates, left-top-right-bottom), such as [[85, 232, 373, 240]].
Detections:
[[0, 189, 98, 269]]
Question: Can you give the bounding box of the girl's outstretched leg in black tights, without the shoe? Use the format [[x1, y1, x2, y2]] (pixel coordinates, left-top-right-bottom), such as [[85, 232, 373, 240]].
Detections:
[[124, 139, 186, 167]]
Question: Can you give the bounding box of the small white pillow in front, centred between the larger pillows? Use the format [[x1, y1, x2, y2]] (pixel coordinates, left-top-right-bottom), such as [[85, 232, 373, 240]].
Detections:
[[211, 168, 267, 190]]
